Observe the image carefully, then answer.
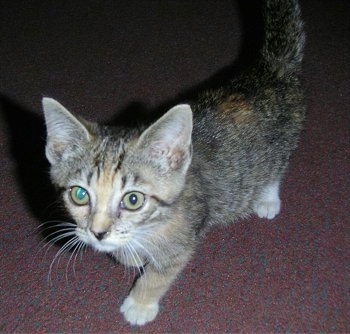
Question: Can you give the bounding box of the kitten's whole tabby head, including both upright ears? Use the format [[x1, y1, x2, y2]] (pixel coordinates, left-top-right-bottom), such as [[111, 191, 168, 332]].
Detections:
[[43, 98, 192, 262]]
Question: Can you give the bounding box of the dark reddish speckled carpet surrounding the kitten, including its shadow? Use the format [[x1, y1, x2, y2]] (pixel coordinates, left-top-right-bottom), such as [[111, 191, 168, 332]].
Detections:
[[0, 0, 350, 333]]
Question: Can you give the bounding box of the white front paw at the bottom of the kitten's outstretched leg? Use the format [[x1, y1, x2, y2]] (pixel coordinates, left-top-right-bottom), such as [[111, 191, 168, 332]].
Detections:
[[120, 296, 159, 326]]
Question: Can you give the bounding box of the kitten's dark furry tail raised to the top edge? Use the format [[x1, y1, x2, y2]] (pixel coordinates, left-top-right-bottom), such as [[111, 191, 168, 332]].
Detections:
[[262, 0, 305, 77]]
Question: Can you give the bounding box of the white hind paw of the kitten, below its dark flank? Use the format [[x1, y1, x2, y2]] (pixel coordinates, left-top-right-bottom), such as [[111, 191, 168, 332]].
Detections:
[[253, 181, 281, 219]]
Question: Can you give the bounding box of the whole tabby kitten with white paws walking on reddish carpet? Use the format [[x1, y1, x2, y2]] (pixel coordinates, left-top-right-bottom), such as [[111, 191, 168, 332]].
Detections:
[[43, 0, 305, 325]]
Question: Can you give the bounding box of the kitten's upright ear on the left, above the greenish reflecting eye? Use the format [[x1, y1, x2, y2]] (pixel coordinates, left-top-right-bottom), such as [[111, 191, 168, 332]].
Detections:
[[42, 97, 91, 164]]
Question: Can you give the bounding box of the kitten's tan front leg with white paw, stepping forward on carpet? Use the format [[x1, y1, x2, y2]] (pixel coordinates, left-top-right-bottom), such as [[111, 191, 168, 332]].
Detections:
[[120, 254, 189, 325]]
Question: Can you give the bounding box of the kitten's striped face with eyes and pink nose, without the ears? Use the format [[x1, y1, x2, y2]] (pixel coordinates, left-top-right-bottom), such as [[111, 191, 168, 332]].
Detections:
[[60, 139, 184, 252]]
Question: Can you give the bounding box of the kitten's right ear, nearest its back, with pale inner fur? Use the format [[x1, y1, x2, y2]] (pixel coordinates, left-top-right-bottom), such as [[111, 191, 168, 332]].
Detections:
[[139, 104, 192, 170]]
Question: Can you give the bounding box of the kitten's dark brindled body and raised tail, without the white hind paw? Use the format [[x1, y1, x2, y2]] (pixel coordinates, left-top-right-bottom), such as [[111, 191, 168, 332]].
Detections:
[[187, 0, 305, 227]]
